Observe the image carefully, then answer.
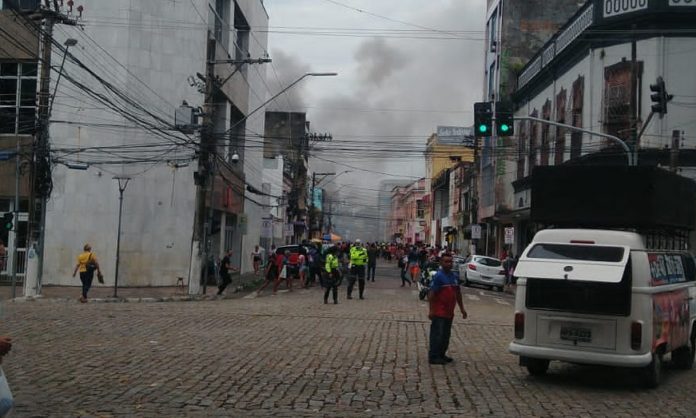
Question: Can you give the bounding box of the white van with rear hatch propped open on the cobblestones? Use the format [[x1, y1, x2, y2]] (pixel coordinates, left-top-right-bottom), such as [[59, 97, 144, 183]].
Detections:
[[509, 229, 696, 387]]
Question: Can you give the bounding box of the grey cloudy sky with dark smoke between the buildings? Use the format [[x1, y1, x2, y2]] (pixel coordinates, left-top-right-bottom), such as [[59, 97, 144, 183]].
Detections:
[[264, 0, 486, 240]]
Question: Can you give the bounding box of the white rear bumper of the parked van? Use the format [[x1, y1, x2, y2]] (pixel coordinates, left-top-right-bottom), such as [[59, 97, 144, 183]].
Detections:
[[508, 341, 652, 367]]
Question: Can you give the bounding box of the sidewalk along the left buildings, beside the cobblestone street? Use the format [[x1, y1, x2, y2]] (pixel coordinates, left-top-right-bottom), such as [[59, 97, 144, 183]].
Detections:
[[0, 272, 261, 302]]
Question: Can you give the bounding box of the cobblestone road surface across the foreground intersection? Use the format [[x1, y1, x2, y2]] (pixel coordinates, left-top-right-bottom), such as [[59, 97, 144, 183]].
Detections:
[[2, 265, 696, 417]]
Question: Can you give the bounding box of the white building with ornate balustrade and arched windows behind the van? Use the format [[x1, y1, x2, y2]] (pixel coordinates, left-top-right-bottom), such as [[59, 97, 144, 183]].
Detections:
[[505, 0, 696, 254]]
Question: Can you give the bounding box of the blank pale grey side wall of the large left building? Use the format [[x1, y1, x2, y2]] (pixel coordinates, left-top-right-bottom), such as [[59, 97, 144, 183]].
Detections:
[[43, 0, 222, 286]]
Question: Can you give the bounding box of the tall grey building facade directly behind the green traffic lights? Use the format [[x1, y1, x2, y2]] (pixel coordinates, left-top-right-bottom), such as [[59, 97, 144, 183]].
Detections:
[[477, 0, 583, 255]]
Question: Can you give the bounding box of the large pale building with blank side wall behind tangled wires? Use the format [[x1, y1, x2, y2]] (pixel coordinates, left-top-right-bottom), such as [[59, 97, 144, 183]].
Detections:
[[43, 0, 268, 292]]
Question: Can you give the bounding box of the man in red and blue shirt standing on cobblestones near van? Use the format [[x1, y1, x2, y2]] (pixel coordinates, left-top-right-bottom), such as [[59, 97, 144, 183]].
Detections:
[[428, 253, 467, 364]]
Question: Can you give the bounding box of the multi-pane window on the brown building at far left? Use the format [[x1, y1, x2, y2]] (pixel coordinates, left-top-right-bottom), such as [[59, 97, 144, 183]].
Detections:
[[0, 62, 37, 134]]
